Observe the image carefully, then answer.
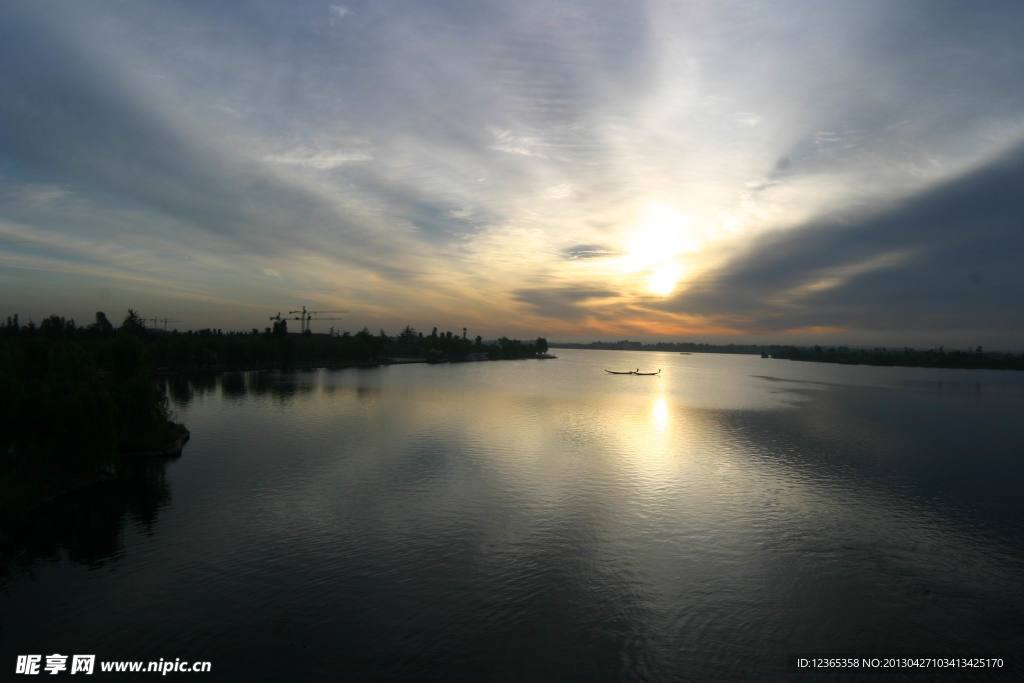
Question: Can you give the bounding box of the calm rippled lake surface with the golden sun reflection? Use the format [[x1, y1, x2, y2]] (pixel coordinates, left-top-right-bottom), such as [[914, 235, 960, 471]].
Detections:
[[0, 350, 1024, 681]]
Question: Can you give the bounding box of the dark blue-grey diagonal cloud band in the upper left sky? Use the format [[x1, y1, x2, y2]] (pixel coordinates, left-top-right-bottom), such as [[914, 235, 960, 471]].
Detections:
[[0, 13, 344, 258]]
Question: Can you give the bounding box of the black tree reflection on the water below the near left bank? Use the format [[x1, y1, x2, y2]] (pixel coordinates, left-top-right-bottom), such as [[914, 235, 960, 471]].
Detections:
[[0, 459, 171, 585]]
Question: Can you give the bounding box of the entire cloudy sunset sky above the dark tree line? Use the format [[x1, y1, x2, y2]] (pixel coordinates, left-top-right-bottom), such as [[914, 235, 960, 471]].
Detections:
[[0, 0, 1024, 348]]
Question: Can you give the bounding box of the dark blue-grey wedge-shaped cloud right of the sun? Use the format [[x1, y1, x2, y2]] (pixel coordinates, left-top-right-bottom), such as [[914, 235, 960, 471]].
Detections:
[[665, 145, 1024, 344]]
